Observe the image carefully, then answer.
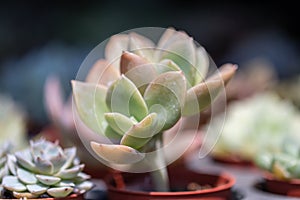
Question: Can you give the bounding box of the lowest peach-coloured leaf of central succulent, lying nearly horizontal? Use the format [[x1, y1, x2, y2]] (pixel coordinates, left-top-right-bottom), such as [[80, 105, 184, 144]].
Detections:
[[91, 142, 145, 164]]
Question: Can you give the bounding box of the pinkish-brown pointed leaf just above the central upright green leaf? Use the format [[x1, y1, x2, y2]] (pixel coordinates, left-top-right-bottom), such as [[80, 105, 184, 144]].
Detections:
[[120, 52, 157, 94]]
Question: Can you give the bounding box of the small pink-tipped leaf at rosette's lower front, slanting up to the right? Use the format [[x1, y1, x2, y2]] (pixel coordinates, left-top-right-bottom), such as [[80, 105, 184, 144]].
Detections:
[[121, 113, 164, 149]]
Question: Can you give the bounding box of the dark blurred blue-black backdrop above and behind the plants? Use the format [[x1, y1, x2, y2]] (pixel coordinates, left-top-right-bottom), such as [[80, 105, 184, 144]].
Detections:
[[0, 0, 300, 133]]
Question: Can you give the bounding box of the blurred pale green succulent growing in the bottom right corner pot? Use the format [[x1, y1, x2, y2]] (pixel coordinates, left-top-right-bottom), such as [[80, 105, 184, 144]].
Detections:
[[255, 139, 300, 180]]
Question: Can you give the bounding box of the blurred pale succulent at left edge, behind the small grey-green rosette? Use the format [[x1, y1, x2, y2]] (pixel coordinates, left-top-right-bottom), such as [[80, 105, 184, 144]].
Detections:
[[0, 94, 27, 149]]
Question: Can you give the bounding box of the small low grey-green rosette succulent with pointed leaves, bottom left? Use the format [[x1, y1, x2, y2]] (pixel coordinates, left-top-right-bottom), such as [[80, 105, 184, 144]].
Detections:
[[2, 139, 93, 198]]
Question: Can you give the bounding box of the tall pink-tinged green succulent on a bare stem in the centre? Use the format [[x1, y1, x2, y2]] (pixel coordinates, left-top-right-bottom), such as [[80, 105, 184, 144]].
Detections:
[[72, 28, 237, 190]]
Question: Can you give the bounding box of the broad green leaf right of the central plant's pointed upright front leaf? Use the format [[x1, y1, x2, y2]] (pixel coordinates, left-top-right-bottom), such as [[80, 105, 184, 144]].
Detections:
[[144, 71, 186, 130]]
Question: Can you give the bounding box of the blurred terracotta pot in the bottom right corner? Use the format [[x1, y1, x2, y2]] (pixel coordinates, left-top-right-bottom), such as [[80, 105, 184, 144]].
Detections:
[[264, 173, 300, 197]]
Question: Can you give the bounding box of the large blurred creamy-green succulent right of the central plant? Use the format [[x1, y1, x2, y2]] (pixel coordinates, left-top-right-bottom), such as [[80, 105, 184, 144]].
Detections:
[[209, 92, 300, 161]]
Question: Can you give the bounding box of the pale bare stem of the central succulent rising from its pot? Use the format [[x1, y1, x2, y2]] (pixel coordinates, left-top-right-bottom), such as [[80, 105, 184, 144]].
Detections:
[[151, 133, 170, 192]]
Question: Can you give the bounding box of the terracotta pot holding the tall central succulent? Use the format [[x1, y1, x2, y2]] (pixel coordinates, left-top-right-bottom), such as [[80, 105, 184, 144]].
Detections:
[[106, 168, 235, 200]]
